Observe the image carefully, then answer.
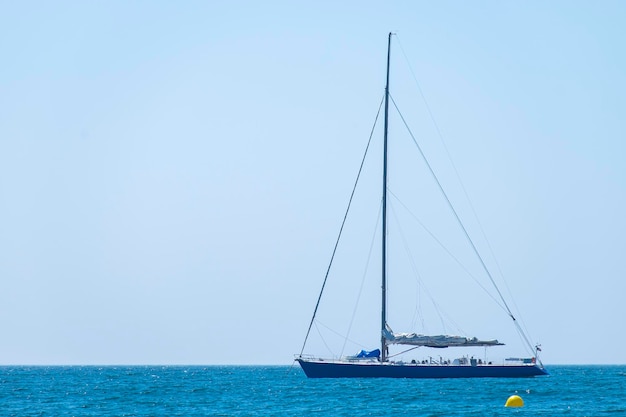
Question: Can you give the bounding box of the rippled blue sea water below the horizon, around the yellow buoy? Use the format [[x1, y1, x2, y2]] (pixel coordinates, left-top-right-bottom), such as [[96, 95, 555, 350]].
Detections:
[[0, 366, 626, 417]]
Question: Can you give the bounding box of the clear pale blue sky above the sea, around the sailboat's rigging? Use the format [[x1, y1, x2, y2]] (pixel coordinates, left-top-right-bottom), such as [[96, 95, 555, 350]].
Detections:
[[0, 1, 626, 364]]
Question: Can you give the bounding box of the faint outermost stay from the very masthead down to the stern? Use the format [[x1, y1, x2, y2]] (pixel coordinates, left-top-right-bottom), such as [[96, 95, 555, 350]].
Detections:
[[396, 34, 529, 352]]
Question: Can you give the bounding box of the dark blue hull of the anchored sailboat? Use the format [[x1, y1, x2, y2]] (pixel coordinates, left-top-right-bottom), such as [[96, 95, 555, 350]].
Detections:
[[296, 358, 548, 378]]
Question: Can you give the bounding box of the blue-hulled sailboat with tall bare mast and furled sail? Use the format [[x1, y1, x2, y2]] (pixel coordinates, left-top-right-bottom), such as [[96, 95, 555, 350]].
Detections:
[[295, 33, 547, 378]]
